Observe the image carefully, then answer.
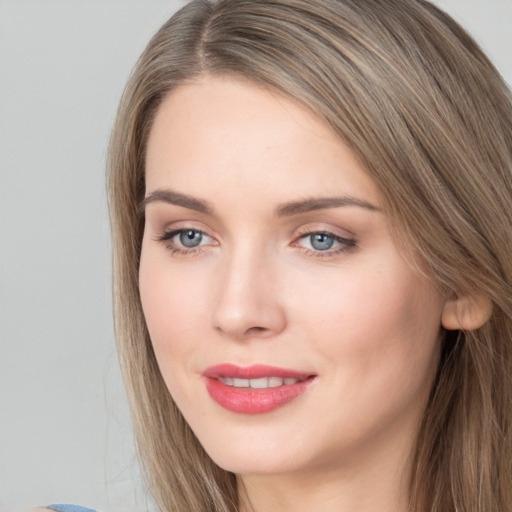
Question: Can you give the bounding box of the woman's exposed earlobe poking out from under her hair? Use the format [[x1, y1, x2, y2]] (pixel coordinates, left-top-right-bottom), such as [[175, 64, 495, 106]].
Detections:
[[441, 294, 492, 331]]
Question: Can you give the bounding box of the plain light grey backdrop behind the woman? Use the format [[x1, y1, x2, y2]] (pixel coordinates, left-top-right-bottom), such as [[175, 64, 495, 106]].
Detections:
[[0, 0, 512, 512]]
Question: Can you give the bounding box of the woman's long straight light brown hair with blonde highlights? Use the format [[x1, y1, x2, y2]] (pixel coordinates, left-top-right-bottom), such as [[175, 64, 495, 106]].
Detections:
[[108, 0, 512, 512]]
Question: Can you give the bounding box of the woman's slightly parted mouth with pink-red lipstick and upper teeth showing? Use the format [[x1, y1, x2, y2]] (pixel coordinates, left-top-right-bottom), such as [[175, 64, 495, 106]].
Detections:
[[202, 364, 315, 414]]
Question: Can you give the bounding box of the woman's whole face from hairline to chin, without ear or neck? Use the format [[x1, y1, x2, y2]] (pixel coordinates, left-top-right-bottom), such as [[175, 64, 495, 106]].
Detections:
[[140, 78, 444, 480]]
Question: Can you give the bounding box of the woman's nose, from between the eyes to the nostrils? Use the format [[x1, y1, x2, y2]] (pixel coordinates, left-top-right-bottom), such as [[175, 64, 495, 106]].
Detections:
[[212, 250, 286, 340]]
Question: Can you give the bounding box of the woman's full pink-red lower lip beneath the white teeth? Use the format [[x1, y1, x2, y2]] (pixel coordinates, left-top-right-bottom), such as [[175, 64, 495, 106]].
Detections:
[[206, 377, 313, 414]]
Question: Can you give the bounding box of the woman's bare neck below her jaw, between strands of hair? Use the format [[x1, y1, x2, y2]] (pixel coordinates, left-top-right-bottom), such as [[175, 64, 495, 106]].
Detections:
[[237, 430, 411, 512]]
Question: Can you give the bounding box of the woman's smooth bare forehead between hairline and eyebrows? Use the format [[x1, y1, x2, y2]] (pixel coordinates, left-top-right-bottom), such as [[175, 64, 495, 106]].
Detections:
[[146, 78, 378, 208]]
